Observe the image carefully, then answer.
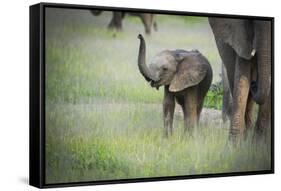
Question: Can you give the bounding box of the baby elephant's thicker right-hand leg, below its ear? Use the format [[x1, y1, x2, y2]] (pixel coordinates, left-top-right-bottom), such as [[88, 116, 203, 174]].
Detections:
[[183, 87, 198, 132]]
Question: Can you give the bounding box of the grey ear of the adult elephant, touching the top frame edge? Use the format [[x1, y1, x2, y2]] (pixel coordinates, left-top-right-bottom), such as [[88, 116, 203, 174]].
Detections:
[[209, 17, 255, 59]]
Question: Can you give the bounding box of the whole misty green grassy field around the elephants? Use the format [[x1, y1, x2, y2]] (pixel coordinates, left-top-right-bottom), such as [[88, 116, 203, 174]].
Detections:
[[46, 9, 271, 183]]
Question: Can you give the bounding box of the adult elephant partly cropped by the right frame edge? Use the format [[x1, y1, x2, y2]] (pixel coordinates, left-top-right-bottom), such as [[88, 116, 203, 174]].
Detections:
[[209, 17, 272, 140]]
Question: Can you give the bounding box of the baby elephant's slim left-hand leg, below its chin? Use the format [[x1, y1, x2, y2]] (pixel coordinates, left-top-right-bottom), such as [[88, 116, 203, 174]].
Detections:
[[163, 86, 175, 137]]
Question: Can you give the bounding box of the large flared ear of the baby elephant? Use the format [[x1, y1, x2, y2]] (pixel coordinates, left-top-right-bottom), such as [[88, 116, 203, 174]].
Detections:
[[169, 56, 208, 92]]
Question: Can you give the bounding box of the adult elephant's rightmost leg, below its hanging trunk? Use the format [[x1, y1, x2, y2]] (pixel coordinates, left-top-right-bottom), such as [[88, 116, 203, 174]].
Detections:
[[255, 90, 271, 137]]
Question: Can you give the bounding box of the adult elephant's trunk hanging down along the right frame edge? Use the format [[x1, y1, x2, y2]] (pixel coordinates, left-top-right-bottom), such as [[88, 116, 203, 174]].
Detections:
[[251, 21, 271, 105]]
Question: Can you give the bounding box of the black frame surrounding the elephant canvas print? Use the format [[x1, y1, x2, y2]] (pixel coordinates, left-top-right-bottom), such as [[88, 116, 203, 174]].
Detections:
[[29, 3, 274, 188]]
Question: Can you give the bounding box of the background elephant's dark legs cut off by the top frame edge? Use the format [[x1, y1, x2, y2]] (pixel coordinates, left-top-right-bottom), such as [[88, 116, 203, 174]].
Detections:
[[91, 10, 157, 34]]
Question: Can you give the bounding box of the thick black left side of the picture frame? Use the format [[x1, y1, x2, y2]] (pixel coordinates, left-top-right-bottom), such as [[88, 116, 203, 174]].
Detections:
[[29, 3, 45, 188]]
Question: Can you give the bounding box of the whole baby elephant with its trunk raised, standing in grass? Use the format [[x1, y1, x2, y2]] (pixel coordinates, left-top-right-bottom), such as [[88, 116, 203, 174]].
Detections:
[[138, 35, 213, 136]]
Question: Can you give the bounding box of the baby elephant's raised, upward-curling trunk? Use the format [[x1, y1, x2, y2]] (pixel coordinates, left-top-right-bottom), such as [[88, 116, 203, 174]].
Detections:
[[138, 34, 155, 82]]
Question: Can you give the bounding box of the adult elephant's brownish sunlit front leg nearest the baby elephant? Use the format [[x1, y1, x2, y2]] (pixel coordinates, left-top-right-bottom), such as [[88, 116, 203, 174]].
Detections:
[[229, 56, 251, 142]]
